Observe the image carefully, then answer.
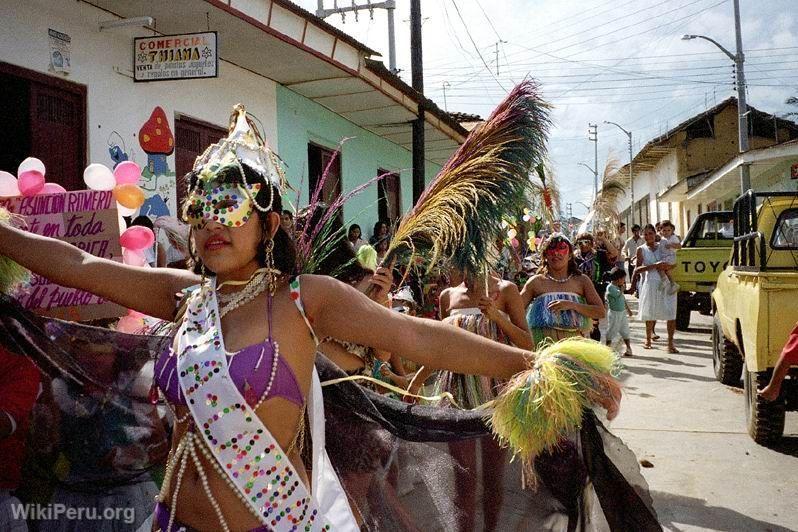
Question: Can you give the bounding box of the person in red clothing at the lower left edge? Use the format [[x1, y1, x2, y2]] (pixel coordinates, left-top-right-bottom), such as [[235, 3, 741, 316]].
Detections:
[[0, 347, 40, 532]]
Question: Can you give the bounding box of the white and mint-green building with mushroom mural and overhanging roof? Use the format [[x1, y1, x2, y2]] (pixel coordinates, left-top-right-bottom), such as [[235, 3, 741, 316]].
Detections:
[[0, 0, 467, 233]]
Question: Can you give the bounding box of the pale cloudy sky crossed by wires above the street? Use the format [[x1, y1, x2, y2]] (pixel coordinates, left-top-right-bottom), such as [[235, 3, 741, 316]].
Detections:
[[295, 0, 798, 216]]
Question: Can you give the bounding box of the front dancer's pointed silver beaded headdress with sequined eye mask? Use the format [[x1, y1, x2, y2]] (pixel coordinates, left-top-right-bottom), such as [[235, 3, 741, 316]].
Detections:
[[184, 104, 286, 227]]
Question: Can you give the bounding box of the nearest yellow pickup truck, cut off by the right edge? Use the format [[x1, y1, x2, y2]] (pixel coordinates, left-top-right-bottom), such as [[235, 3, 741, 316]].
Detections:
[[712, 191, 798, 444]]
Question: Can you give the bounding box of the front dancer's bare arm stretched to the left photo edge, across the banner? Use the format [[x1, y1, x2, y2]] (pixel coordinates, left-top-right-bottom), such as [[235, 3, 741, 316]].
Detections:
[[0, 224, 199, 320]]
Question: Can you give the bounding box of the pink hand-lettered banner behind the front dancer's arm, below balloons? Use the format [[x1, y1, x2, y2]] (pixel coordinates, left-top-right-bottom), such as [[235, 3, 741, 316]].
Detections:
[[0, 190, 125, 321]]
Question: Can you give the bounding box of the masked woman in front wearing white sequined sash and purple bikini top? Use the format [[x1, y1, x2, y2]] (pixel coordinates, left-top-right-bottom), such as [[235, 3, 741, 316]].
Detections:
[[0, 106, 588, 530]]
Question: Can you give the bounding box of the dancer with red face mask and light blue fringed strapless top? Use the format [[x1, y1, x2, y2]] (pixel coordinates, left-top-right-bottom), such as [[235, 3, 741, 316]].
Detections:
[[521, 233, 606, 348]]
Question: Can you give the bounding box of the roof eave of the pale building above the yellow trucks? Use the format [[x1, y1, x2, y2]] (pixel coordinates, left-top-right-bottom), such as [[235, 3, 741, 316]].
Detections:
[[686, 141, 798, 201]]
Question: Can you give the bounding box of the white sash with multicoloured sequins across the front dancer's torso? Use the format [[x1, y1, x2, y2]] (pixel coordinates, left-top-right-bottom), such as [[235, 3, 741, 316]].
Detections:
[[177, 280, 337, 532]]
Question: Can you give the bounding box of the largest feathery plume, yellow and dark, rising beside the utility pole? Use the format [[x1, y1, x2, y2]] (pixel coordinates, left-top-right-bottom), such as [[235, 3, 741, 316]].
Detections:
[[383, 80, 551, 274]]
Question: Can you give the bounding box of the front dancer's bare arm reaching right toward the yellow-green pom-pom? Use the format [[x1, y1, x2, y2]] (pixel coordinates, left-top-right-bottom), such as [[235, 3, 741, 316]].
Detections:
[[302, 275, 531, 378]]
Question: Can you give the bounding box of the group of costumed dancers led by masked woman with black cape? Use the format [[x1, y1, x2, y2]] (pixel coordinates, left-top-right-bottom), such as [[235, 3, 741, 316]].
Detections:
[[0, 103, 659, 532]]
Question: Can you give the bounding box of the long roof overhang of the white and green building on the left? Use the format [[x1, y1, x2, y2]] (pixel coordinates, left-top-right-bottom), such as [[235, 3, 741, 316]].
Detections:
[[86, 0, 467, 164]]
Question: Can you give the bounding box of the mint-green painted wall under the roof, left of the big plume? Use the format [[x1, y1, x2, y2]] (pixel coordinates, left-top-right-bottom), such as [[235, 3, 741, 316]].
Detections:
[[277, 85, 440, 238]]
